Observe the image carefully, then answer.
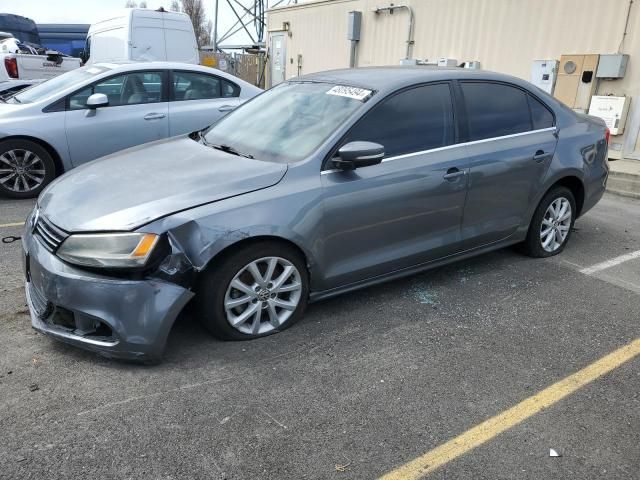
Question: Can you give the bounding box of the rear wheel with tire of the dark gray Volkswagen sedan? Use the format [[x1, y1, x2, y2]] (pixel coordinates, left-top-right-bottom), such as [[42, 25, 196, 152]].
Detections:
[[523, 186, 577, 258]]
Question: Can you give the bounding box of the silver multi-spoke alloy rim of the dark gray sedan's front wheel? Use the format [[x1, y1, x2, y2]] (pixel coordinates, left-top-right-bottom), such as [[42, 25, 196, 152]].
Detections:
[[224, 257, 302, 335]]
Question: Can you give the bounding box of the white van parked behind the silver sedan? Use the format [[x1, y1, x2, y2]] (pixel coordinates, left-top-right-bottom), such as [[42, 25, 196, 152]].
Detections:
[[84, 8, 200, 65]]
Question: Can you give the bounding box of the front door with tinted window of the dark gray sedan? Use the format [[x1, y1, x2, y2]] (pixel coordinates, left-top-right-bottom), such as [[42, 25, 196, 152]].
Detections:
[[322, 83, 467, 288]]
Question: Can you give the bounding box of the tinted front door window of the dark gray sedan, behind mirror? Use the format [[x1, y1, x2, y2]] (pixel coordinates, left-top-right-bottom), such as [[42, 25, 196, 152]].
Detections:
[[343, 84, 454, 157]]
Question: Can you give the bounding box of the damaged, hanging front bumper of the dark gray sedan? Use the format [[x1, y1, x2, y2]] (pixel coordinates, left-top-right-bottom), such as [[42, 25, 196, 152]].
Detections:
[[22, 228, 193, 362]]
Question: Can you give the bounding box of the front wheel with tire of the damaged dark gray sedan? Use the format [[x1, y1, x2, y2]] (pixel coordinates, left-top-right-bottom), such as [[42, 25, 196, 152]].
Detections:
[[196, 242, 309, 340]]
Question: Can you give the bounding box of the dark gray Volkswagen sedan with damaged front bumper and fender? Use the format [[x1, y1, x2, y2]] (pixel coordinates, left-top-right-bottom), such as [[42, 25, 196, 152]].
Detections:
[[23, 67, 608, 361]]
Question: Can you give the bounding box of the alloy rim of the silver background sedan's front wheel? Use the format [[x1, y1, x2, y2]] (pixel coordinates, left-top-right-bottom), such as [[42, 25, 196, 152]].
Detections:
[[0, 149, 45, 193]]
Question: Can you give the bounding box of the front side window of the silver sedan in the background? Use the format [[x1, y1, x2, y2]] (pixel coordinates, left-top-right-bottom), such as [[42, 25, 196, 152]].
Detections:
[[69, 72, 162, 110]]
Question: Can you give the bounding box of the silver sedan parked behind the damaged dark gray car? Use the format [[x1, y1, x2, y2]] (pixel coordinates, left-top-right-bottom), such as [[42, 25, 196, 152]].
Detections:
[[0, 62, 262, 198]]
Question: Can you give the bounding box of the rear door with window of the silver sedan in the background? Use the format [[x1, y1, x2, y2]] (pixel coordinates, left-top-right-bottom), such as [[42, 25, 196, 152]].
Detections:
[[169, 70, 240, 136]]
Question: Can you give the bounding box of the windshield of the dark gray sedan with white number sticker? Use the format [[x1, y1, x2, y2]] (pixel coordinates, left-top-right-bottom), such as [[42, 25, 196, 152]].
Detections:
[[205, 82, 372, 163]]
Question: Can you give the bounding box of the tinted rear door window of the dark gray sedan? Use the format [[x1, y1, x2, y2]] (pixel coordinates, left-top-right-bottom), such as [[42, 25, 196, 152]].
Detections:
[[460, 82, 532, 141]]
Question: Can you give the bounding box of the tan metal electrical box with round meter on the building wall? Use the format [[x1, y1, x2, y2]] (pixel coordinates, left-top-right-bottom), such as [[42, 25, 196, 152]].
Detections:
[[553, 54, 600, 113]]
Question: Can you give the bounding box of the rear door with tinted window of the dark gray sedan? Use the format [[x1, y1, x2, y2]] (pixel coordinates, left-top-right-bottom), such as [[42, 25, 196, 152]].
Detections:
[[459, 81, 557, 249]]
